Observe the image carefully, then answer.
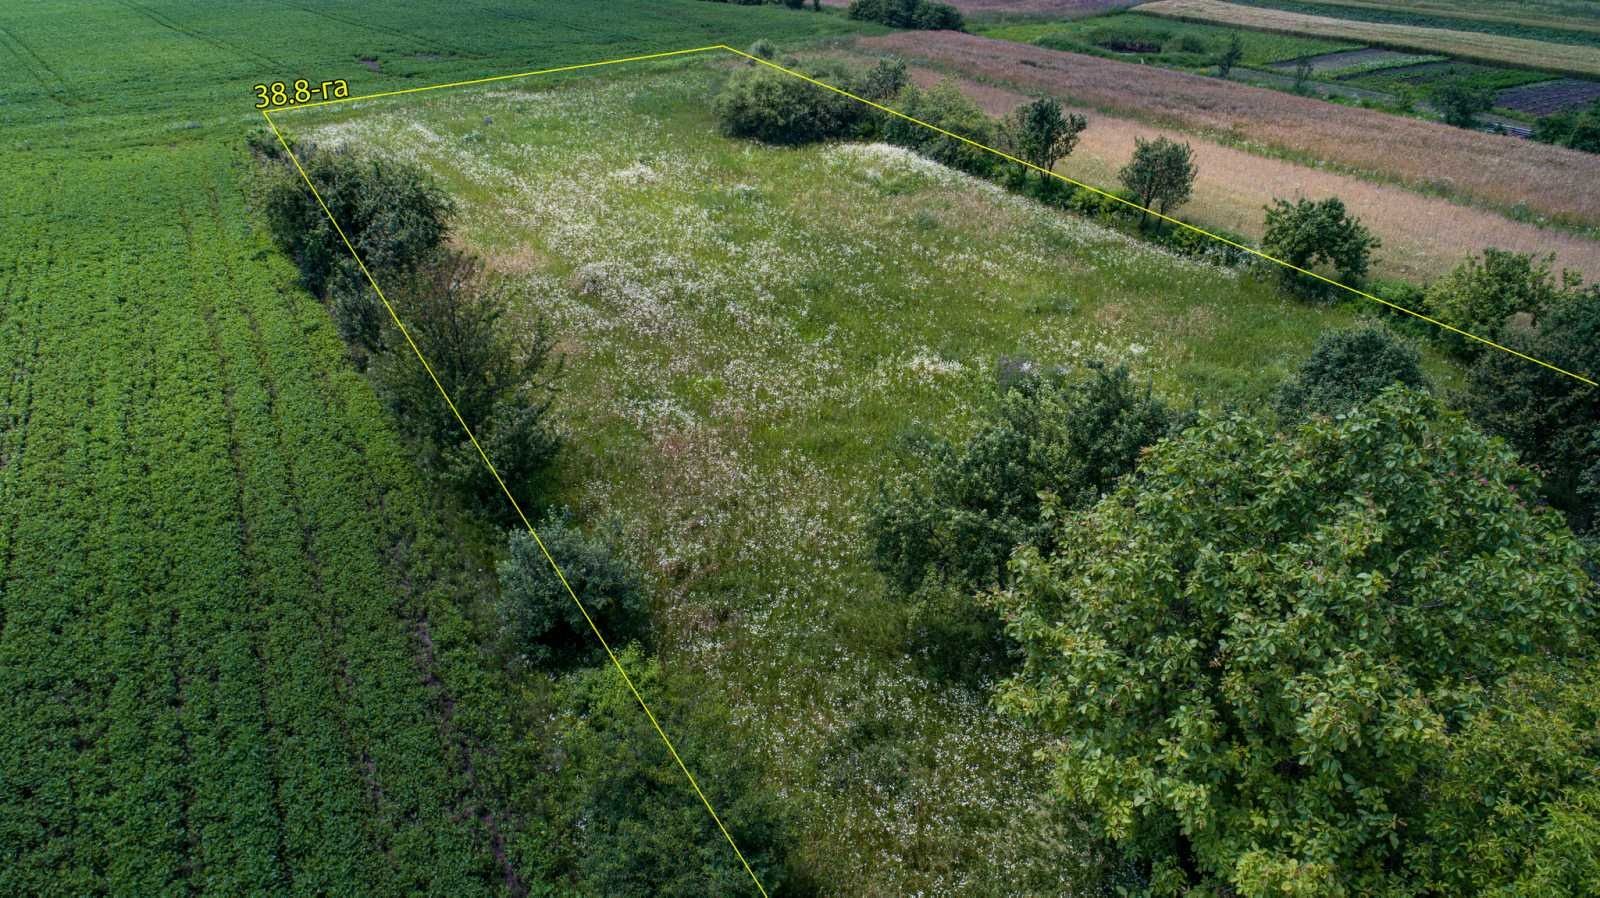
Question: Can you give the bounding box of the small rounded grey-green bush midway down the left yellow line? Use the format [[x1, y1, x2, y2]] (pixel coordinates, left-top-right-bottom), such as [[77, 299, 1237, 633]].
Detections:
[[498, 511, 650, 664]]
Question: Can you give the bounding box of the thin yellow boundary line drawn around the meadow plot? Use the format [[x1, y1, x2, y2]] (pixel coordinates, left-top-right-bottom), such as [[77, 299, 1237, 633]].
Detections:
[[261, 43, 1600, 898]]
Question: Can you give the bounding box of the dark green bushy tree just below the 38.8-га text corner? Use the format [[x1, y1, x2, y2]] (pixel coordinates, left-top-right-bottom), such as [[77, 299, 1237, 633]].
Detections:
[[266, 146, 454, 296]]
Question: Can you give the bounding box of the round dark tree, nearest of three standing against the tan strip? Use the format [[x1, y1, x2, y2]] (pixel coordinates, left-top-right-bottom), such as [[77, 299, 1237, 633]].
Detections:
[[1261, 197, 1382, 295]]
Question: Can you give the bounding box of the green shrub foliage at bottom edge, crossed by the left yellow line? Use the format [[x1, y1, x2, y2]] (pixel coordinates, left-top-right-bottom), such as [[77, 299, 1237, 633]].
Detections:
[[554, 648, 808, 898]]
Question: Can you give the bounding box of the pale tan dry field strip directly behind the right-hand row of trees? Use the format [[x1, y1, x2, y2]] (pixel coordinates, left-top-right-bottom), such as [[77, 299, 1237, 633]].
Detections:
[[912, 69, 1600, 280]]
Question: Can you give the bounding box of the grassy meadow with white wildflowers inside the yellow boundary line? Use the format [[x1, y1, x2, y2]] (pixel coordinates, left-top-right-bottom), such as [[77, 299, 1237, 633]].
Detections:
[[265, 61, 1451, 895]]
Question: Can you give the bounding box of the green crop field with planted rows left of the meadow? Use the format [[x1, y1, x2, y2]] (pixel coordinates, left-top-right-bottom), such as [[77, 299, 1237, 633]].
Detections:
[[0, 145, 540, 895]]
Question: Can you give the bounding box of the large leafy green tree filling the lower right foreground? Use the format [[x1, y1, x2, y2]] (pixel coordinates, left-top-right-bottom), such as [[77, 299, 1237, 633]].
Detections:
[[995, 387, 1592, 896]]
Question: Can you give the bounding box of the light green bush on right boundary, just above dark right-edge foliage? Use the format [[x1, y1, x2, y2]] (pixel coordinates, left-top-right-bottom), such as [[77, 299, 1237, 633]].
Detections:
[[1424, 247, 1570, 352]]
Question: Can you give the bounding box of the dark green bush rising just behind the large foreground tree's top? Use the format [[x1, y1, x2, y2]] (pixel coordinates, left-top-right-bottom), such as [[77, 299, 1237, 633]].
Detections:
[[1274, 325, 1427, 421]]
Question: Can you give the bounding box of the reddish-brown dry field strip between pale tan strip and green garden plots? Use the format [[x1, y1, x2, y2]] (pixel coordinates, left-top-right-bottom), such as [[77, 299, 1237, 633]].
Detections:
[[861, 32, 1600, 226]]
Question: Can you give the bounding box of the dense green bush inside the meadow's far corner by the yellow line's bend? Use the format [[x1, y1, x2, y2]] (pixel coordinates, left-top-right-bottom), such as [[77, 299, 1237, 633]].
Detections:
[[712, 66, 864, 144]]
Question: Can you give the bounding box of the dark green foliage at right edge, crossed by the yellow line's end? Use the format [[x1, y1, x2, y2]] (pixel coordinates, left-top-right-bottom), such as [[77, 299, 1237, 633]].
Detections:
[[1467, 287, 1600, 531]]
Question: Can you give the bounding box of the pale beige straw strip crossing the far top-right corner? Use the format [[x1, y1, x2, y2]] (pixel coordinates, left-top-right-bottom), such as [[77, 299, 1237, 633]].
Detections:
[[1139, 0, 1600, 75]]
